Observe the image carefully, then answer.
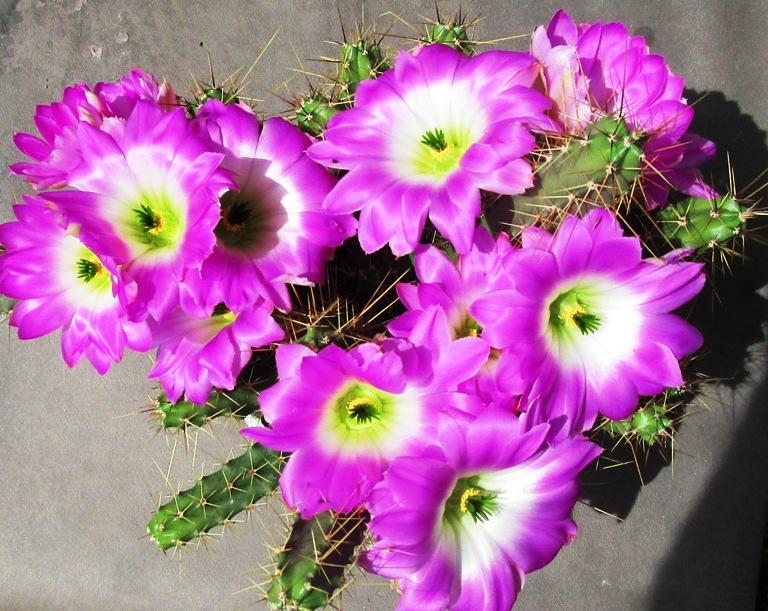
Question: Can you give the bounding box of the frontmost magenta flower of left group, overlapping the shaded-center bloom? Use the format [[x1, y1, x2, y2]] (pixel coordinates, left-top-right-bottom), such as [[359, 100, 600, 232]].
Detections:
[[43, 101, 232, 320]]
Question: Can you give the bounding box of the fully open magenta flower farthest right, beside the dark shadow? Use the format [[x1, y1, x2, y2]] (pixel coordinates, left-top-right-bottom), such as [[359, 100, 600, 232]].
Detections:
[[472, 209, 705, 432]]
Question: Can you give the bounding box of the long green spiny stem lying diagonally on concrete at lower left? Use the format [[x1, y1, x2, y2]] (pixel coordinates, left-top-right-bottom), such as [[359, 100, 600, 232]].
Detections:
[[147, 444, 285, 550]]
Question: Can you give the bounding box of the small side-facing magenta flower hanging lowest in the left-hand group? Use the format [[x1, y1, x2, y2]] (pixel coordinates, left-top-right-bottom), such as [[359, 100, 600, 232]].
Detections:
[[148, 301, 284, 405]]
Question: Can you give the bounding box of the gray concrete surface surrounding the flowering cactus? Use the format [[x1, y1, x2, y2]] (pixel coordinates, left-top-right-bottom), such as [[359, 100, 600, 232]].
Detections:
[[0, 0, 768, 610]]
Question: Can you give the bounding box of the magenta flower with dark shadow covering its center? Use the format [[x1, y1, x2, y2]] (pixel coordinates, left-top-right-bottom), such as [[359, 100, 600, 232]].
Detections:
[[188, 100, 356, 311]]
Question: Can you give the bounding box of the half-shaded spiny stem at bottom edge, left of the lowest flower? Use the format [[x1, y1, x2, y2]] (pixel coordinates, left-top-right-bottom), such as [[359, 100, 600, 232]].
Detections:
[[267, 511, 368, 610]]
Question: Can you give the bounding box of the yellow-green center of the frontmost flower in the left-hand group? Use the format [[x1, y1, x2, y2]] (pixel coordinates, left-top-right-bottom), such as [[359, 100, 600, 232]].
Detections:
[[129, 193, 184, 250]]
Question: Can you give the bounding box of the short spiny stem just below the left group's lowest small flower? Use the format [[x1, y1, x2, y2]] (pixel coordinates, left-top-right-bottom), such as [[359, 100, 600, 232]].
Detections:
[[155, 387, 259, 430]]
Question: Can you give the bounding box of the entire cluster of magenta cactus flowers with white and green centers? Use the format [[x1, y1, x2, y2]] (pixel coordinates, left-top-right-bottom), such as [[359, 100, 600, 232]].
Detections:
[[0, 12, 714, 609]]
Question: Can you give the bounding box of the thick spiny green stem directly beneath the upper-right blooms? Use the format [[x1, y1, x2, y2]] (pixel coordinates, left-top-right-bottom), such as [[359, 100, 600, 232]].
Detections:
[[507, 116, 643, 234]]
